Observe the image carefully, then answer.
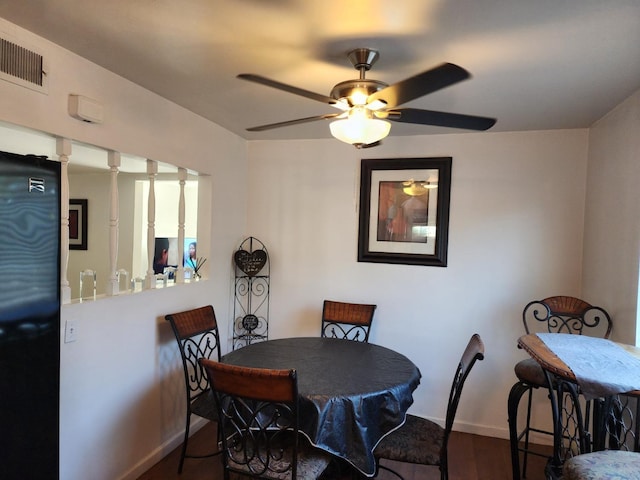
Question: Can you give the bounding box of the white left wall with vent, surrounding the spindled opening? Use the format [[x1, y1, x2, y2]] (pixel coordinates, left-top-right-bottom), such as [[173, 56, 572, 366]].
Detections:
[[0, 19, 247, 480]]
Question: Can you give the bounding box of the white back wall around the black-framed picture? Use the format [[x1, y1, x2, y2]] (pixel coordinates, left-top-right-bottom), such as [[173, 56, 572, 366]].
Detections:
[[248, 130, 588, 438]]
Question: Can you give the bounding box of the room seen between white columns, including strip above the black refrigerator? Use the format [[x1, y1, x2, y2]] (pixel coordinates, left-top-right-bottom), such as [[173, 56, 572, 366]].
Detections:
[[0, 122, 198, 299]]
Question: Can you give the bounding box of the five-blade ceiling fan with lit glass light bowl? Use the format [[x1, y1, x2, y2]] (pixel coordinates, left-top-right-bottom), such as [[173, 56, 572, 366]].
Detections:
[[238, 48, 496, 148]]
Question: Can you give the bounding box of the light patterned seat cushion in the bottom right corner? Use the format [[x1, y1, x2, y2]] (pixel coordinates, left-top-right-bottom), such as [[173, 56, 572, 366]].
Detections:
[[562, 450, 640, 480]]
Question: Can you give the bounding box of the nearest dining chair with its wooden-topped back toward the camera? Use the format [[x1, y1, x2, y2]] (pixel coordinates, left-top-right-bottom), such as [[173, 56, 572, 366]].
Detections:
[[200, 359, 331, 480]]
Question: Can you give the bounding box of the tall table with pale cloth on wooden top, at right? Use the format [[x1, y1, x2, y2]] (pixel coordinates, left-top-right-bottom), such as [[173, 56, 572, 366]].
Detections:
[[518, 333, 640, 476]]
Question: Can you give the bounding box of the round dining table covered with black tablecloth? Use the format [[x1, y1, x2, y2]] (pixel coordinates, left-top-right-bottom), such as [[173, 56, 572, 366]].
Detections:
[[221, 337, 421, 477]]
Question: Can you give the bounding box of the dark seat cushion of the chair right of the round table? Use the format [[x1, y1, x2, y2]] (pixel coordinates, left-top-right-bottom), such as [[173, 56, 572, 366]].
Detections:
[[373, 415, 444, 465]]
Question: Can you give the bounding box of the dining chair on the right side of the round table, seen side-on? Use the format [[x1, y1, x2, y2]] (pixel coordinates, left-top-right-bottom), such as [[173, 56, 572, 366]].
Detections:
[[373, 333, 484, 480]]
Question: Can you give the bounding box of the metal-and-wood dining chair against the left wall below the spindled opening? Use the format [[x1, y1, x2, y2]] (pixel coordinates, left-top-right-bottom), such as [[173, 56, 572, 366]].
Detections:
[[165, 305, 220, 473]]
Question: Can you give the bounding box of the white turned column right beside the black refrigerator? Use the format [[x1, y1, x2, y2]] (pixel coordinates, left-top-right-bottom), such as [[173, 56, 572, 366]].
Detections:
[[56, 138, 71, 304]]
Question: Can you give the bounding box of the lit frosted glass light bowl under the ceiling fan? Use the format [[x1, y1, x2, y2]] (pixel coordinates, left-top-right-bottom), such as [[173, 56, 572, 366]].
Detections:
[[329, 108, 391, 147]]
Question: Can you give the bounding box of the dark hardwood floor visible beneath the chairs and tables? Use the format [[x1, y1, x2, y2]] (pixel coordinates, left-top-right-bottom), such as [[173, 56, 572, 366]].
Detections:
[[138, 424, 546, 480]]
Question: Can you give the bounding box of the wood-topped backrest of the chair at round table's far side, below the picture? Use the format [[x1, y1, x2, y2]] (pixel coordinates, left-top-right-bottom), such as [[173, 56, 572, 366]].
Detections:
[[320, 300, 376, 342]]
